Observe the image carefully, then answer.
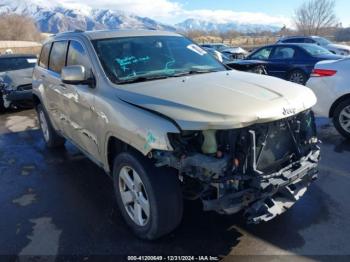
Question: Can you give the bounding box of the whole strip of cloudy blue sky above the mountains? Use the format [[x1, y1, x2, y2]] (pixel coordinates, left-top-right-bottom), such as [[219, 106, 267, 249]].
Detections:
[[60, 0, 350, 26]]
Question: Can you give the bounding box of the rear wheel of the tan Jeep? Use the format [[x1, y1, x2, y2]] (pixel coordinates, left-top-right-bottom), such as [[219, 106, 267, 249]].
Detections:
[[36, 104, 66, 148]]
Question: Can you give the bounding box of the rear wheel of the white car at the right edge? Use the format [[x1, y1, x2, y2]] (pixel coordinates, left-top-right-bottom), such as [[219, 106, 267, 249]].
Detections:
[[333, 99, 350, 139]]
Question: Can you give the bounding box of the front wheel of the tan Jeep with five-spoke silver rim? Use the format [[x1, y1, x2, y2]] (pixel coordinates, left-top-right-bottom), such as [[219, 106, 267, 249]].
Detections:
[[113, 152, 183, 240]]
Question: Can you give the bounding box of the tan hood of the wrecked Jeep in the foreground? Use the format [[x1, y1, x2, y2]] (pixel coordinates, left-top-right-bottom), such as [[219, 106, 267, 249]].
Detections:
[[117, 70, 316, 130]]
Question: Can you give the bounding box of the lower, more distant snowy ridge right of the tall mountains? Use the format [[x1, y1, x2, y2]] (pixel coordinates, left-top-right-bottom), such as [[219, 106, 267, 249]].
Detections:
[[175, 18, 281, 33]]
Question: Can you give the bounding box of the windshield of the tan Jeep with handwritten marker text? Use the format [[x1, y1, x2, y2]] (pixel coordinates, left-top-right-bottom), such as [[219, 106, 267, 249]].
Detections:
[[93, 36, 226, 84]]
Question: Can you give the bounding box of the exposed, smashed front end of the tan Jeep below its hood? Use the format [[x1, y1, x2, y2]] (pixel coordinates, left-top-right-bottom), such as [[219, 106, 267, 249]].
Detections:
[[152, 110, 320, 223]]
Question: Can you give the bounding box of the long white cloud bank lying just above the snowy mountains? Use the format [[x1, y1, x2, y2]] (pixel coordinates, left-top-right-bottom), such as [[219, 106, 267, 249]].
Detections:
[[60, 0, 291, 26]]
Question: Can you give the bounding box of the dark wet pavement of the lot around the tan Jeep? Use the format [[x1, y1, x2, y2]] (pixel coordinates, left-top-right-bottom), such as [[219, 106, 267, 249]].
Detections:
[[0, 110, 350, 261]]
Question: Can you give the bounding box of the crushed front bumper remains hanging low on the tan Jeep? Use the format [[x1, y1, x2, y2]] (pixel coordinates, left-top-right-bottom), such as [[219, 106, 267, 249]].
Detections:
[[203, 150, 320, 223]]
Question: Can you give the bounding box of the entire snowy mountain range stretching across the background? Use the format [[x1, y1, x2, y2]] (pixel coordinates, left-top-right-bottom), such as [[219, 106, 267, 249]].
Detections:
[[0, 0, 279, 33]]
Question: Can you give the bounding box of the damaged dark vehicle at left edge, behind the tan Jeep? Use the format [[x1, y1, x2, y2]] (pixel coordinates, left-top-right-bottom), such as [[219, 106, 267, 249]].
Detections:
[[0, 54, 37, 112]]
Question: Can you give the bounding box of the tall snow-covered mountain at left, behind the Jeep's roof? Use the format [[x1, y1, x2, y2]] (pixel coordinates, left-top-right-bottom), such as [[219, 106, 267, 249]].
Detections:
[[0, 0, 175, 33]]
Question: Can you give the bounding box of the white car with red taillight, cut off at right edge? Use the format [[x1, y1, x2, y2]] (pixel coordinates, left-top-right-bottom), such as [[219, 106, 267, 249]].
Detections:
[[306, 58, 350, 139]]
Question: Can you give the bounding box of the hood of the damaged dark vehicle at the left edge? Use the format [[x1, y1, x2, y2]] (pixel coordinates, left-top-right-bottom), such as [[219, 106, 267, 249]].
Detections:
[[0, 68, 33, 88]]
